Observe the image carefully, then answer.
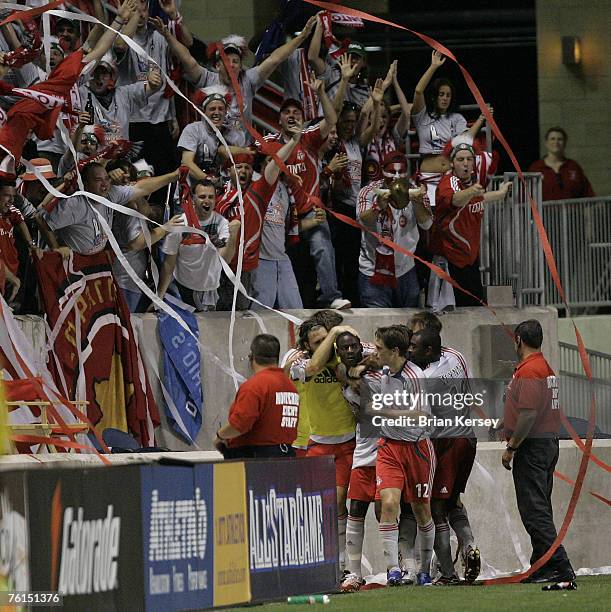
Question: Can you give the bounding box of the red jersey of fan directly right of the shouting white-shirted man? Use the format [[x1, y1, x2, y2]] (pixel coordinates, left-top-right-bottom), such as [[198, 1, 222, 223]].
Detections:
[[215, 176, 276, 272]]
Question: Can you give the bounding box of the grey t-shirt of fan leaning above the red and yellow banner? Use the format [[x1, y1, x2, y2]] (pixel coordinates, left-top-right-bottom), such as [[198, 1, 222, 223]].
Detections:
[[42, 185, 135, 255]]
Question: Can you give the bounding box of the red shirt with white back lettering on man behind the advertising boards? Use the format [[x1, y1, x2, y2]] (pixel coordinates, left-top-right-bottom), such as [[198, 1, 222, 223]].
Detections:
[[229, 368, 299, 448]]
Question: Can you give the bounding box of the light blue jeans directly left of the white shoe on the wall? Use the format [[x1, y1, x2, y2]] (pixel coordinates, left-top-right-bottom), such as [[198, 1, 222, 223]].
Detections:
[[251, 258, 303, 309]]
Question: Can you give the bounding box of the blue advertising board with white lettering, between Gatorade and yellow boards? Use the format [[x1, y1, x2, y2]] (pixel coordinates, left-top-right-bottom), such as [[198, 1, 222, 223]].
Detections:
[[141, 464, 215, 612]]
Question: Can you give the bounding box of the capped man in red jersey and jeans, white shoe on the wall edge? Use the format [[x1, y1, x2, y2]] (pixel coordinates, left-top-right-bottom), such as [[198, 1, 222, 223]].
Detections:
[[265, 74, 351, 308]]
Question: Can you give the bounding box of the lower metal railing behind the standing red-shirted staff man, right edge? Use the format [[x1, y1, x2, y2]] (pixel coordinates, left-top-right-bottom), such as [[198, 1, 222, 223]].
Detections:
[[558, 342, 611, 433]]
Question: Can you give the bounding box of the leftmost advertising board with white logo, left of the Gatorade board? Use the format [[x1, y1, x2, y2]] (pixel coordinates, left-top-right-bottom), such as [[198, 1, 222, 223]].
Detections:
[[0, 472, 30, 604]]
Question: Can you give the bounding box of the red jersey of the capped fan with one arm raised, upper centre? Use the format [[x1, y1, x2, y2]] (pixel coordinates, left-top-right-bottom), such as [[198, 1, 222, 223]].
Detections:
[[264, 125, 326, 217]]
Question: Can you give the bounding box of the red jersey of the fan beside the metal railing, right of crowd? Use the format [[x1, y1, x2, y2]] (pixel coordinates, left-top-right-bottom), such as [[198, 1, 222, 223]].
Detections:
[[429, 174, 484, 268]]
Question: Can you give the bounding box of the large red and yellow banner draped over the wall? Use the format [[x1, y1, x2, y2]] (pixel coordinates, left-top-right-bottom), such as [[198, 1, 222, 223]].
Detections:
[[35, 252, 159, 446]]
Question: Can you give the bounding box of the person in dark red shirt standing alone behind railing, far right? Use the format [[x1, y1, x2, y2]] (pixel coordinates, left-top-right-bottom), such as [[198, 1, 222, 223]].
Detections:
[[528, 127, 594, 200]]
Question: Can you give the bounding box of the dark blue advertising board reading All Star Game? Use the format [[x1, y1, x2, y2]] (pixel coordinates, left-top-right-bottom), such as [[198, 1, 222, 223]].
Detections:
[[245, 457, 339, 602]]
